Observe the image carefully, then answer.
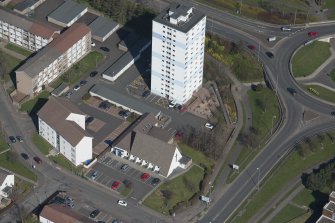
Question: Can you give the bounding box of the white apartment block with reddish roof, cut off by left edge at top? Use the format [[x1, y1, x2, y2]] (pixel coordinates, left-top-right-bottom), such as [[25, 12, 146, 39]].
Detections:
[[0, 8, 60, 51]]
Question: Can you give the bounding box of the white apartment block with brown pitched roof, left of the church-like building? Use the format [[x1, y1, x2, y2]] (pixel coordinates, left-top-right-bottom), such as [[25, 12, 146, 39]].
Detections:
[[37, 96, 93, 166]]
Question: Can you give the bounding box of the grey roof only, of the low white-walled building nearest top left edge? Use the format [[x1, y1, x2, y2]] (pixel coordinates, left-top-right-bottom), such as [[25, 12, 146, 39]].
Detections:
[[48, 0, 87, 24]]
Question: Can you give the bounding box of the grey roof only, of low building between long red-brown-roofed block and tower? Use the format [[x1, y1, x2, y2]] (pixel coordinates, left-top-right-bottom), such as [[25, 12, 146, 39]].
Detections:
[[89, 16, 119, 38]]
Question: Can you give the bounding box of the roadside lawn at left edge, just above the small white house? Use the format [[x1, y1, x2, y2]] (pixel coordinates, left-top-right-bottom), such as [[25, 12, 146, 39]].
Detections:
[[0, 151, 37, 181]]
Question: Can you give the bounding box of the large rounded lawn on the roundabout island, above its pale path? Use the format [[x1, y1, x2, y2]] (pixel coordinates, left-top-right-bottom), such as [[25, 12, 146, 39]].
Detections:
[[292, 41, 331, 77]]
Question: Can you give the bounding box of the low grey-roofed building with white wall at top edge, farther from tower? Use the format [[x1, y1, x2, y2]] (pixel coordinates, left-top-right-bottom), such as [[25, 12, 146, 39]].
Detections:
[[47, 0, 87, 27]]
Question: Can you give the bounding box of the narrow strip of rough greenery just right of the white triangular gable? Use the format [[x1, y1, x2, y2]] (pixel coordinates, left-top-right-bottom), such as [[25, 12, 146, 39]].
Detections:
[[178, 143, 215, 172]]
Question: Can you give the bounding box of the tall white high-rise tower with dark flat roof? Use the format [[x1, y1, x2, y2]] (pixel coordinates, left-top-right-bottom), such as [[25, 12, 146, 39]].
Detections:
[[151, 4, 206, 104]]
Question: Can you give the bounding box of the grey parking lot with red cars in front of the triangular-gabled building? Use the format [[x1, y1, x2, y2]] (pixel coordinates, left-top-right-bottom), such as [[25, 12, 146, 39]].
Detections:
[[86, 153, 162, 201]]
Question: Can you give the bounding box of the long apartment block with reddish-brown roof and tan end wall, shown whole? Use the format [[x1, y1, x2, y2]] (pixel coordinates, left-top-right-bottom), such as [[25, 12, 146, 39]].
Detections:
[[15, 23, 91, 96]]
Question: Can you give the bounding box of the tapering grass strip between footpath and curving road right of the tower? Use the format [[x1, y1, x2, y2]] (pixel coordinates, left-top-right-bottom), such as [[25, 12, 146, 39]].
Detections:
[[227, 87, 279, 183]]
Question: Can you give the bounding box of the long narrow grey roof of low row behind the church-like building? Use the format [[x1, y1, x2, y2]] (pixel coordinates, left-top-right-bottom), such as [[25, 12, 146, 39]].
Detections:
[[90, 84, 160, 115]]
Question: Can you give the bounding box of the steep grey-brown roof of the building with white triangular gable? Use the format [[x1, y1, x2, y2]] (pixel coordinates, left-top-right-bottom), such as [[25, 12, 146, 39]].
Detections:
[[130, 132, 176, 176]]
